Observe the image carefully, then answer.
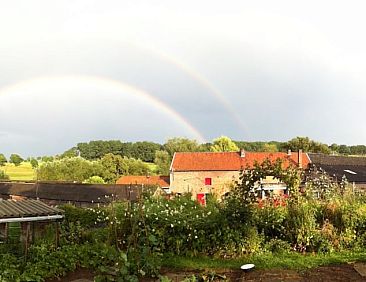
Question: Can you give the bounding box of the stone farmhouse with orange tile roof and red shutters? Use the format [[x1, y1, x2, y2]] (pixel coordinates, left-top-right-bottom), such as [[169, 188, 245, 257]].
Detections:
[[170, 150, 310, 200]]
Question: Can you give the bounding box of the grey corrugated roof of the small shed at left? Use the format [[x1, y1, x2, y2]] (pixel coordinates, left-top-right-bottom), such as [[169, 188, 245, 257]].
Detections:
[[0, 199, 63, 219]]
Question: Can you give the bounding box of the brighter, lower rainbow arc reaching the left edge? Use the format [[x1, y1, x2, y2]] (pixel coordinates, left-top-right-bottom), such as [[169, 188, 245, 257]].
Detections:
[[0, 75, 206, 143]]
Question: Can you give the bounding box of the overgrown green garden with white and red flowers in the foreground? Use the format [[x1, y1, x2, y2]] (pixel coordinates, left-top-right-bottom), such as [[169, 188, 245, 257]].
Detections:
[[0, 162, 366, 281]]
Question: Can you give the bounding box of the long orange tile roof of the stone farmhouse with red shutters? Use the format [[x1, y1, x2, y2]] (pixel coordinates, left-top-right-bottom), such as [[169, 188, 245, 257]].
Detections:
[[171, 152, 310, 171]]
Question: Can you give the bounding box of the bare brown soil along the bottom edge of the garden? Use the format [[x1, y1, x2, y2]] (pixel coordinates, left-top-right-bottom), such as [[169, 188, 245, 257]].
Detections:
[[47, 264, 366, 282]]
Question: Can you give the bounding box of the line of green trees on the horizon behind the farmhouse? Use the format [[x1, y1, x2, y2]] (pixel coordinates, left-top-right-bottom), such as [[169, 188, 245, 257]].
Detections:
[[0, 136, 366, 183]]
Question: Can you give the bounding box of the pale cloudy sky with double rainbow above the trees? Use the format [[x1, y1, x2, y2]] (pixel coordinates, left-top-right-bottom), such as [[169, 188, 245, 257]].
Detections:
[[0, 0, 366, 157]]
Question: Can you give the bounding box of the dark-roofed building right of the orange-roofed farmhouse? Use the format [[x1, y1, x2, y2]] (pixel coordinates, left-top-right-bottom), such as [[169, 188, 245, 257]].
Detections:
[[309, 153, 366, 190]]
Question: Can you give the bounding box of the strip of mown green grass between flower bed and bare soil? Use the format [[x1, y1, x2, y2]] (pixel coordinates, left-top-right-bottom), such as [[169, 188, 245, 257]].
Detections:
[[163, 251, 366, 270]]
